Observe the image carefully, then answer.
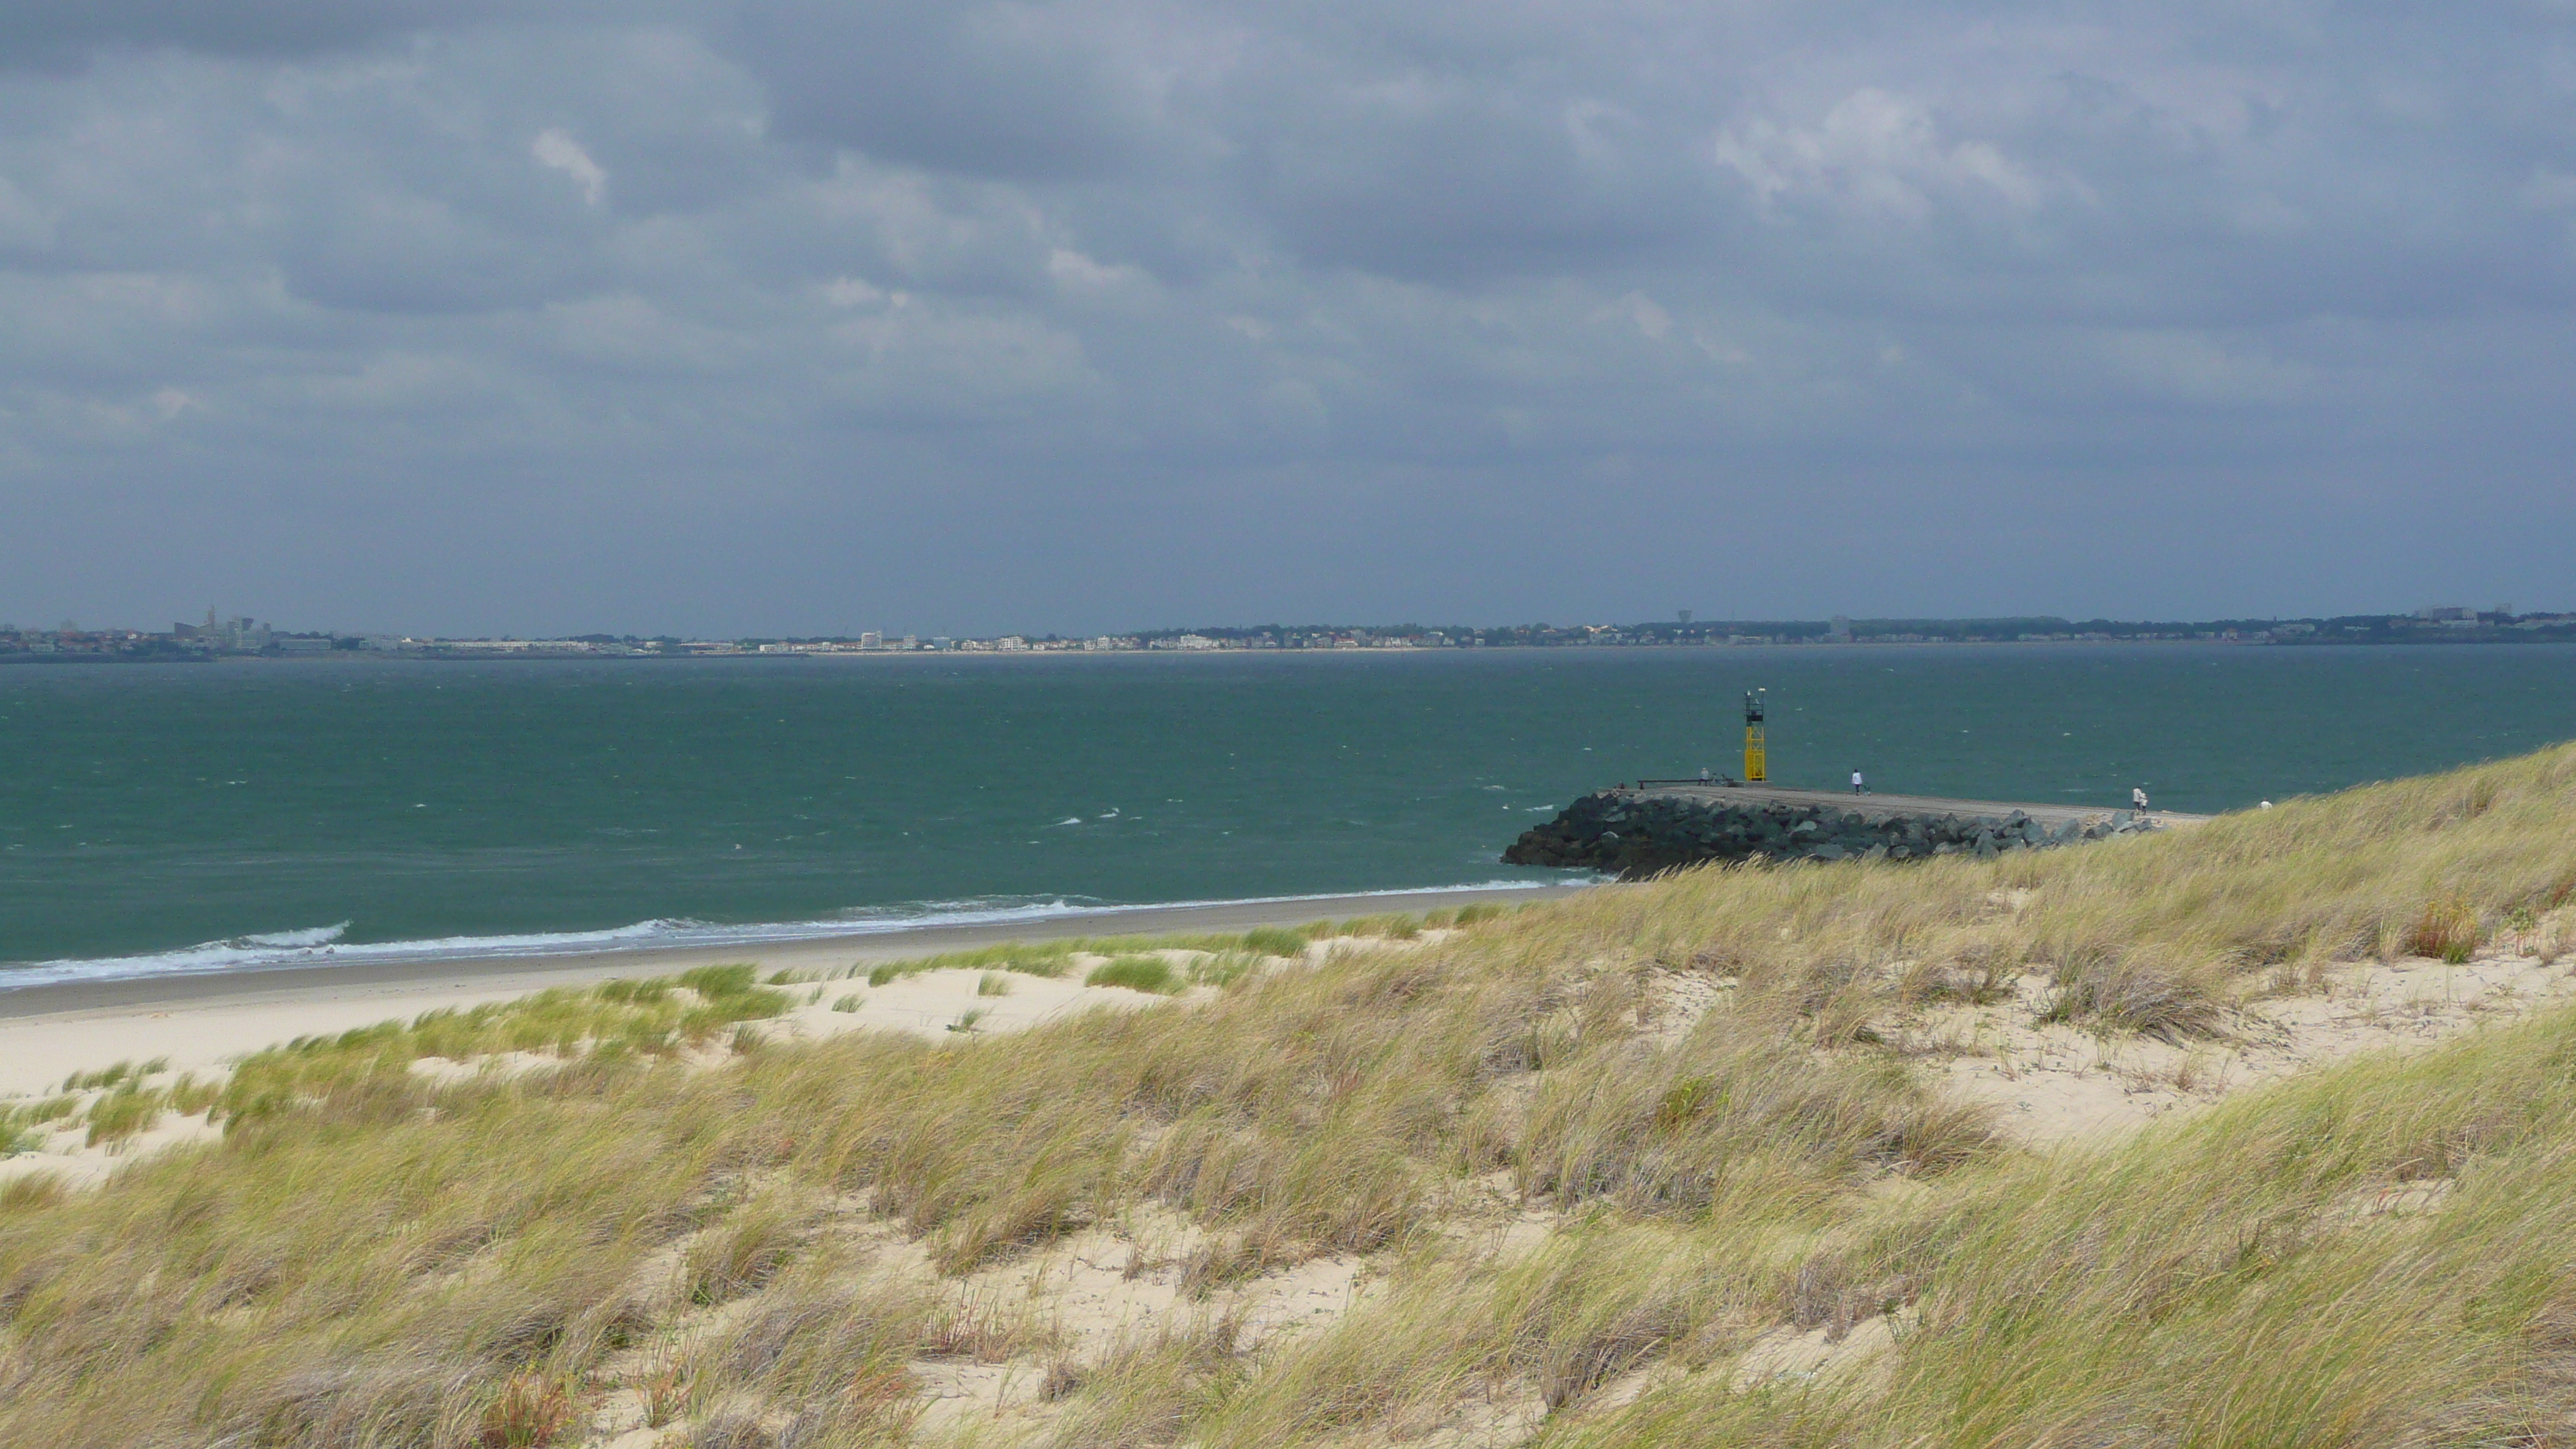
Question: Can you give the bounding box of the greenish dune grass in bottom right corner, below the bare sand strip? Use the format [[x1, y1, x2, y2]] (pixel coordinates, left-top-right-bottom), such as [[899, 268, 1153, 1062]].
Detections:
[[1548, 1011, 2576, 1447]]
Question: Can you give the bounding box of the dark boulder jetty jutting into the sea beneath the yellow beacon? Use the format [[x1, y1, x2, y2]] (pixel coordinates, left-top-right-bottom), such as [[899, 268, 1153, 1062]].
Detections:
[[1502, 789, 2159, 879]]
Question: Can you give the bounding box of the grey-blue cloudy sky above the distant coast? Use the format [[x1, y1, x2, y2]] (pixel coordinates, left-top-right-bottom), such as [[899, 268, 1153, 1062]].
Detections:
[[0, 0, 2576, 634]]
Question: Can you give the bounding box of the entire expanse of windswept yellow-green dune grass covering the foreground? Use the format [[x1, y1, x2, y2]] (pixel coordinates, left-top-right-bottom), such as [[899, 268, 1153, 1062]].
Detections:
[[0, 748, 2576, 1449]]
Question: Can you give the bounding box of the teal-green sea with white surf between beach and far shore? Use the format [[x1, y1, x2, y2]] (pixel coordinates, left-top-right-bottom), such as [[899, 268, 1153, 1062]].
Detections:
[[0, 645, 2576, 982]]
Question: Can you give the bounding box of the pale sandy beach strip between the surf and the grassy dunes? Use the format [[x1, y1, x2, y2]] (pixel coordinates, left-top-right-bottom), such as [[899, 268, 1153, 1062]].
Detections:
[[0, 887, 1587, 1096]]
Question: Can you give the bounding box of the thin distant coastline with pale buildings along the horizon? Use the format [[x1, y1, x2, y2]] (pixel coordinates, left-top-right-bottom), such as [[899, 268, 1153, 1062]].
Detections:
[[0, 606, 2576, 663]]
